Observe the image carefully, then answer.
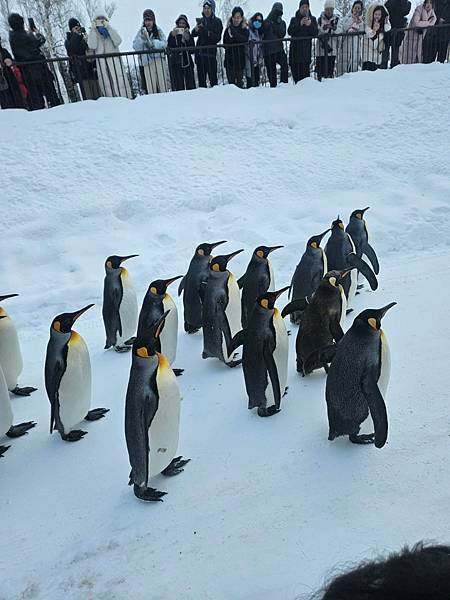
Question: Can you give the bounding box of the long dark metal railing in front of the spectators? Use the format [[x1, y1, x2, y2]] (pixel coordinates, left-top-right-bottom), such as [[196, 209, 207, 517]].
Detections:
[[1, 25, 450, 110]]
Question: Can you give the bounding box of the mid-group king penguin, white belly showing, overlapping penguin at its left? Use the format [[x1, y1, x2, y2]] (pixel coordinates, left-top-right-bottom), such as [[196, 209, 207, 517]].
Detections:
[[202, 250, 243, 367]]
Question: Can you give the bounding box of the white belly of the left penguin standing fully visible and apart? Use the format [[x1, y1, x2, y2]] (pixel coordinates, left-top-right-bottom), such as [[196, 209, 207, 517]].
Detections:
[[59, 331, 91, 434]]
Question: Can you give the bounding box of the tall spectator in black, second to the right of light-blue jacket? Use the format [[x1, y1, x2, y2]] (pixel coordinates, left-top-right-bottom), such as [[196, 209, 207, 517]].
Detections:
[[192, 0, 223, 87]]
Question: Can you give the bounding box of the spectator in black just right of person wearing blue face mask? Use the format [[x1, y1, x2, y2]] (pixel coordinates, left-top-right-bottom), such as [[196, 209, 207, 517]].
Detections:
[[263, 2, 289, 87]]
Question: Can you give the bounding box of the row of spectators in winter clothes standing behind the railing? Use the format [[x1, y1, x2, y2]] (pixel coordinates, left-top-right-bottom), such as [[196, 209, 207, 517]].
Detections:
[[0, 0, 450, 110]]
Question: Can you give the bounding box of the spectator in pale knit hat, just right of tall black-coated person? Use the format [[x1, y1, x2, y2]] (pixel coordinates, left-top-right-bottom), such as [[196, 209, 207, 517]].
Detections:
[[316, 0, 341, 81]]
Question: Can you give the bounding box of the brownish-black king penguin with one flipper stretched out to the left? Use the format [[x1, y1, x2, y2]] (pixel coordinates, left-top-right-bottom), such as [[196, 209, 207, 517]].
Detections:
[[281, 270, 350, 376]]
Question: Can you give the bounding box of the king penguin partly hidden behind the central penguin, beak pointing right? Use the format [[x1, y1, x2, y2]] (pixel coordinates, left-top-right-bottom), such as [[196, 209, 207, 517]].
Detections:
[[238, 246, 283, 329]]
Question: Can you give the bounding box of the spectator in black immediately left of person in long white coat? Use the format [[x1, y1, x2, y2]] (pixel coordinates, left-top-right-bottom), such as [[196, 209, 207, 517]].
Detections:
[[64, 18, 100, 100]]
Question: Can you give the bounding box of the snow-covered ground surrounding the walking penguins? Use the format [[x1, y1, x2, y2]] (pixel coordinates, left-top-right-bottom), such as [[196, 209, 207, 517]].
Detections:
[[0, 65, 450, 600]]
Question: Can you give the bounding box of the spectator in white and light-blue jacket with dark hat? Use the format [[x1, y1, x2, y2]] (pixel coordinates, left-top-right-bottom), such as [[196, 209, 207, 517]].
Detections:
[[133, 8, 168, 94]]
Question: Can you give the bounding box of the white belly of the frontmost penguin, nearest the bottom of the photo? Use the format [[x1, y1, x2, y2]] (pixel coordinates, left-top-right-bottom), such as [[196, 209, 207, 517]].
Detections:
[[147, 353, 180, 485]]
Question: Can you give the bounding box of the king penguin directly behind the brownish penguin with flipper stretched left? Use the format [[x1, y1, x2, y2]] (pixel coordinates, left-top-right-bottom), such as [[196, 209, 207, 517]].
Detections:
[[290, 229, 331, 324]]
